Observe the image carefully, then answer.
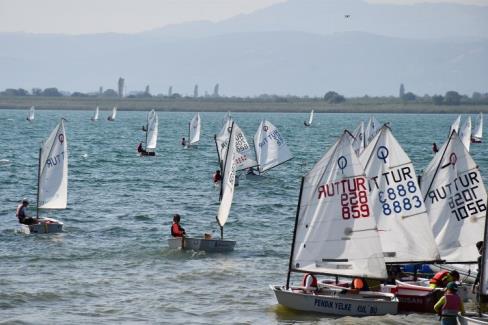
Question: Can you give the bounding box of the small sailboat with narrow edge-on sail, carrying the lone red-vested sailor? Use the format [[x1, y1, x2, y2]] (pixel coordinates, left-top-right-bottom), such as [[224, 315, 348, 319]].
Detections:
[[168, 124, 237, 252]]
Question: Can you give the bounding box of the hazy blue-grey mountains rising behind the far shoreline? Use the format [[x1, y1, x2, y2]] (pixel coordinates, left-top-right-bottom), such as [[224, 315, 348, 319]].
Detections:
[[0, 0, 488, 96]]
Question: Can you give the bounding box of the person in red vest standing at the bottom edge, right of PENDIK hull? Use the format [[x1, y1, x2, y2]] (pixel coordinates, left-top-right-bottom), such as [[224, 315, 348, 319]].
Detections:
[[434, 282, 464, 325]]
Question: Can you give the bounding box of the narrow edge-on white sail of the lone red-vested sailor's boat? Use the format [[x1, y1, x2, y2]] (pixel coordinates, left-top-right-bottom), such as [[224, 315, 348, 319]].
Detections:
[[217, 121, 237, 227]]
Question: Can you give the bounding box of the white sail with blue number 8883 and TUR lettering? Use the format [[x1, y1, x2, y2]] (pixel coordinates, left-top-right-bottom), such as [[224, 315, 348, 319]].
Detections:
[[359, 126, 439, 263]]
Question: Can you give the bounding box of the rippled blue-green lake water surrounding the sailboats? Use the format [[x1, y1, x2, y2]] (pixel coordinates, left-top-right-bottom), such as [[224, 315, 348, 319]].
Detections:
[[0, 110, 488, 324]]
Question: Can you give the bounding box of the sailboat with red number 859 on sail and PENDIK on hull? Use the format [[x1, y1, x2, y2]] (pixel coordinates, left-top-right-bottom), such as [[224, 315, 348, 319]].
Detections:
[[271, 131, 398, 316]]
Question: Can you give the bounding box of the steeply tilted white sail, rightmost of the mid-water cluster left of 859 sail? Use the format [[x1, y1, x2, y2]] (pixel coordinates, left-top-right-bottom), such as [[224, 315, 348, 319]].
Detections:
[[254, 120, 293, 173]]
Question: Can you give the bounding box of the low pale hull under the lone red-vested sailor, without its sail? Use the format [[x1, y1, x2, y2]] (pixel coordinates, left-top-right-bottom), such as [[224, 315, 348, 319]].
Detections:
[[168, 237, 236, 253]]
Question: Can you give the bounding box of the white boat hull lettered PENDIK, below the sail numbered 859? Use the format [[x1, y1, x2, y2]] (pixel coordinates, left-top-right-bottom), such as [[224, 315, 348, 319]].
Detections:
[[270, 286, 398, 316]]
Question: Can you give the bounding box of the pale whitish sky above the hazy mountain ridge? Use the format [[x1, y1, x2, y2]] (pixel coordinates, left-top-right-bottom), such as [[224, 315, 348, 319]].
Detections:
[[0, 0, 488, 34]]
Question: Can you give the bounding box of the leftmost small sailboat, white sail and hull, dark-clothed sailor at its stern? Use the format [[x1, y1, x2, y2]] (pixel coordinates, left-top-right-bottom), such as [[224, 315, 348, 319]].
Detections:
[[21, 119, 68, 234]]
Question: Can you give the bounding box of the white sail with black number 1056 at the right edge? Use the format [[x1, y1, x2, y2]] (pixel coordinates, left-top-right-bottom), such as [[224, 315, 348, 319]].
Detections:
[[421, 132, 487, 263]]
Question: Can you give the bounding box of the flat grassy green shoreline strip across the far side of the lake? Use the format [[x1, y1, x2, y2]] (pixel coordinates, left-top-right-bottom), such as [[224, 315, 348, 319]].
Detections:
[[0, 96, 488, 114]]
